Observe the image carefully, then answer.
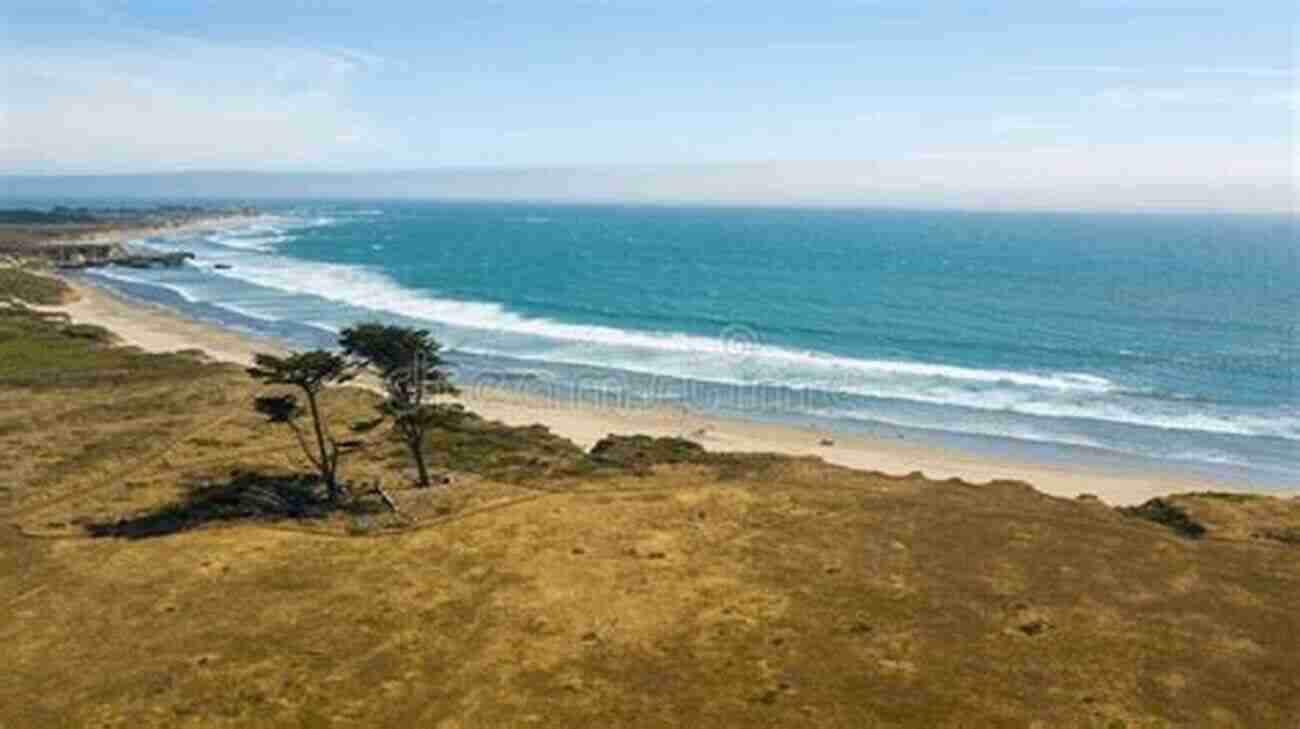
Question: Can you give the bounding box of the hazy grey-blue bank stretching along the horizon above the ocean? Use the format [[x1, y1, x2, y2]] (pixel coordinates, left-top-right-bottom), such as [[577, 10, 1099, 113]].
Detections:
[[0, 160, 1296, 213]]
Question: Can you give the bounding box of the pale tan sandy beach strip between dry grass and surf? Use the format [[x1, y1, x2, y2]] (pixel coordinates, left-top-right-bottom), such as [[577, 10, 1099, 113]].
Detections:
[[50, 277, 1294, 505]]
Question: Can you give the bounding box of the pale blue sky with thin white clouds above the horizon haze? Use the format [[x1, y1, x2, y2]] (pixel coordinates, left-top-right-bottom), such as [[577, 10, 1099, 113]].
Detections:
[[0, 0, 1300, 212]]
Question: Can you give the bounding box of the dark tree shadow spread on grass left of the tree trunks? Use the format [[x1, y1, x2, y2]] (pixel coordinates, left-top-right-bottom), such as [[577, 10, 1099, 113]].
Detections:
[[85, 472, 384, 539]]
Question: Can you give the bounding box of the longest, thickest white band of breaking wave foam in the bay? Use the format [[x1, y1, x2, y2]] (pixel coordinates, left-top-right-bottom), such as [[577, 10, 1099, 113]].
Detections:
[[96, 241, 1300, 444]]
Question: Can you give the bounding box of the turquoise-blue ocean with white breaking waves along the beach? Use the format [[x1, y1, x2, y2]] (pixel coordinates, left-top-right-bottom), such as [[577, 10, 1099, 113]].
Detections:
[[45, 200, 1300, 489]]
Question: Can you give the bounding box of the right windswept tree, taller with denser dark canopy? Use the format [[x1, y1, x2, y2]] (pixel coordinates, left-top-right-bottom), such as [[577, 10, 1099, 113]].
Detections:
[[338, 322, 456, 486]]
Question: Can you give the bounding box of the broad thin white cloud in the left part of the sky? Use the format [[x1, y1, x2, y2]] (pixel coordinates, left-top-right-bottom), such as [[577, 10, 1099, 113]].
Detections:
[[0, 35, 402, 173]]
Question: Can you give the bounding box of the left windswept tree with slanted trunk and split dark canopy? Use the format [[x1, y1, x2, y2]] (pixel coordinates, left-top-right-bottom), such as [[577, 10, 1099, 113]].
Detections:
[[248, 350, 356, 502]]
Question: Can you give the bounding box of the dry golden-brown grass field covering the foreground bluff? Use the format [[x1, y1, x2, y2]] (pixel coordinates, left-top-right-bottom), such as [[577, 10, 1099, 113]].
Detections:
[[0, 302, 1300, 729]]
